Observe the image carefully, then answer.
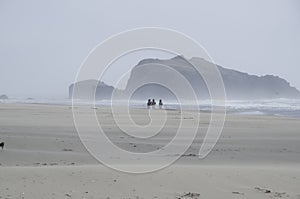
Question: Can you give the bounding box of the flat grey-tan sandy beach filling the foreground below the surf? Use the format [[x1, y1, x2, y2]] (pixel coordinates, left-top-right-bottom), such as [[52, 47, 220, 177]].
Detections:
[[0, 104, 300, 199]]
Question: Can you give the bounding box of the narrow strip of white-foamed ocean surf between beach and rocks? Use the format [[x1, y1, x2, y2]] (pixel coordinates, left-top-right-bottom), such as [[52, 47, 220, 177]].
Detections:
[[0, 99, 300, 118]]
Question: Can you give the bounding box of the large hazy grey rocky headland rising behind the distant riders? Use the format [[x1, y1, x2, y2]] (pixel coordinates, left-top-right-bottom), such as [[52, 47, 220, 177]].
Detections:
[[126, 56, 300, 99]]
